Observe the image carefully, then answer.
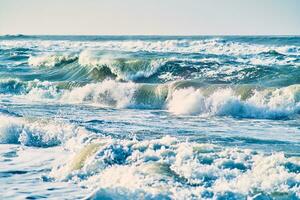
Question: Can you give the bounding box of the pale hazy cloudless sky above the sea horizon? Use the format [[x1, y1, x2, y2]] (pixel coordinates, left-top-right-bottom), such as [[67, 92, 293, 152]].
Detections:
[[0, 0, 300, 35]]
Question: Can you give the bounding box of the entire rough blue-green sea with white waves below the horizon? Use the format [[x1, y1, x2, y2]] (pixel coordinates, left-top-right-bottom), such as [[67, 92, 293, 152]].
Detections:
[[0, 35, 300, 200]]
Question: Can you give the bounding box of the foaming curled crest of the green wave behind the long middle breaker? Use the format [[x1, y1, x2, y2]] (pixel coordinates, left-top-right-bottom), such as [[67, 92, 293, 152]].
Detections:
[[28, 51, 166, 81]]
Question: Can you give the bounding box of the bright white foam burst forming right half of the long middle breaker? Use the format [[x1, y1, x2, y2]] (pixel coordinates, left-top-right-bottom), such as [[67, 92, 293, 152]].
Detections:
[[167, 85, 300, 119]]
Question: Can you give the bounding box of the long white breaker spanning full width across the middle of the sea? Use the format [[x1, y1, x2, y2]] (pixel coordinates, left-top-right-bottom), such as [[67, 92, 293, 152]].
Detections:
[[3, 77, 300, 119]]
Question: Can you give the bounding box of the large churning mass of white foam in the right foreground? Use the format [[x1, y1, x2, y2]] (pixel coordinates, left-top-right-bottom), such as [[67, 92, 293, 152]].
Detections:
[[51, 136, 300, 199]]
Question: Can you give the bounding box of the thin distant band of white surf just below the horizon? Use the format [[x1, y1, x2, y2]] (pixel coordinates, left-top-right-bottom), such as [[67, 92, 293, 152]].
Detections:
[[0, 38, 300, 56]]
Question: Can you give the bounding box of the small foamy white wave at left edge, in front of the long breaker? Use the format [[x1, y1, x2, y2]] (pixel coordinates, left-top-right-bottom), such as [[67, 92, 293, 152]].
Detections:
[[0, 115, 84, 147]]
